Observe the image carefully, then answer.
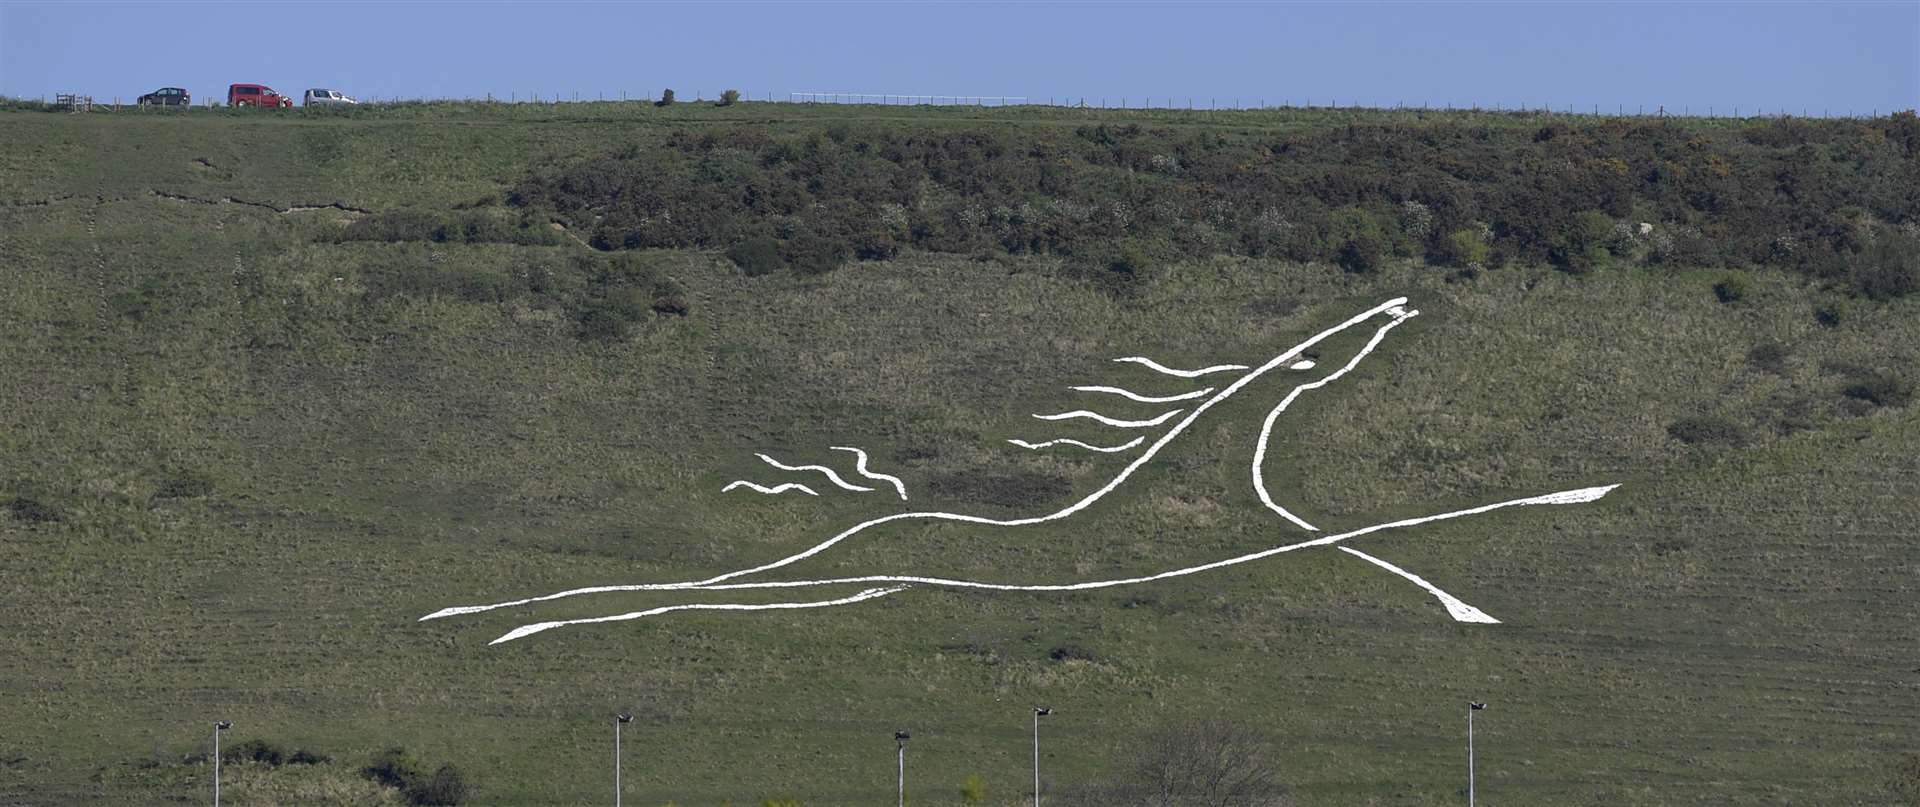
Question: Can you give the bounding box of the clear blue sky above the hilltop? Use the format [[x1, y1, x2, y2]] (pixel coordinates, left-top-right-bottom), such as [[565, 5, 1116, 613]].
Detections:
[[0, 0, 1920, 115]]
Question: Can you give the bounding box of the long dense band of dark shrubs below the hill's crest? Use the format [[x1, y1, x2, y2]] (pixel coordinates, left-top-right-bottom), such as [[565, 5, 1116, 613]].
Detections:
[[509, 111, 1920, 298]]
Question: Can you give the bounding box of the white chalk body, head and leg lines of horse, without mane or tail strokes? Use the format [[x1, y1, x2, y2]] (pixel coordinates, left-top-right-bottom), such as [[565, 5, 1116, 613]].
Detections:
[[420, 298, 1619, 644]]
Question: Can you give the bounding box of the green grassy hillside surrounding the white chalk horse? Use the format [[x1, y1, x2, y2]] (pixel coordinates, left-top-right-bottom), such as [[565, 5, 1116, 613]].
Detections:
[[0, 104, 1920, 805]]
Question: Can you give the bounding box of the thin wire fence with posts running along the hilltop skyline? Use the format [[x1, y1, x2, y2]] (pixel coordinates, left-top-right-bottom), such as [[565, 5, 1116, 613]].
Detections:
[[13, 90, 1899, 119]]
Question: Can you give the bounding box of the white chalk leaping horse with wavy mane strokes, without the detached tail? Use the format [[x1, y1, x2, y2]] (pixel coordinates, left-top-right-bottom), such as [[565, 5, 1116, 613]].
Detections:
[[420, 298, 1615, 644]]
